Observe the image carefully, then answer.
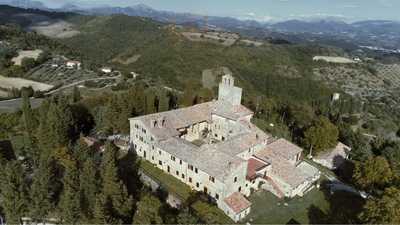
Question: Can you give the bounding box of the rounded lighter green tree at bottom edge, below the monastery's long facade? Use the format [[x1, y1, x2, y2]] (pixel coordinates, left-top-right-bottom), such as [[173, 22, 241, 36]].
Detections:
[[133, 193, 163, 224]]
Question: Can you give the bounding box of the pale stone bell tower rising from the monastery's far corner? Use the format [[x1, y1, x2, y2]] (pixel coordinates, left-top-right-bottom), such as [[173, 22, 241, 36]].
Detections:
[[218, 74, 242, 105]]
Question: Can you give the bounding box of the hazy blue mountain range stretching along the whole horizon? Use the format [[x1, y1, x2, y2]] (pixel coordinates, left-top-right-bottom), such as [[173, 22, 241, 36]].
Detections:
[[0, 0, 400, 52]]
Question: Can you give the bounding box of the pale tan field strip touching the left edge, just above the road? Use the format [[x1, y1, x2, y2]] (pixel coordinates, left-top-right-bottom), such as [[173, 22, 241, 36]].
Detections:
[[0, 76, 53, 91]]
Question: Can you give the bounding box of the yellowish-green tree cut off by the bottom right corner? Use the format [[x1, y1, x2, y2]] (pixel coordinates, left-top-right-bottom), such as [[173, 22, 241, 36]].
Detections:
[[360, 187, 400, 224]]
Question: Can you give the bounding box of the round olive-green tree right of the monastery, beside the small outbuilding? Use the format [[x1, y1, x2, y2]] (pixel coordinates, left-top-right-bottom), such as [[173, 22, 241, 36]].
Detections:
[[304, 117, 339, 154]]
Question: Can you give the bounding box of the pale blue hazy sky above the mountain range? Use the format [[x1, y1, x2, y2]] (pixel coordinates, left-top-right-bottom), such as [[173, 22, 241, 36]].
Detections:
[[41, 0, 400, 22]]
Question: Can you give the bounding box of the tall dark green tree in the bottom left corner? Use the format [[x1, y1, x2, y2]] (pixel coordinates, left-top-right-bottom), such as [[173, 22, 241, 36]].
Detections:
[[0, 161, 28, 224]]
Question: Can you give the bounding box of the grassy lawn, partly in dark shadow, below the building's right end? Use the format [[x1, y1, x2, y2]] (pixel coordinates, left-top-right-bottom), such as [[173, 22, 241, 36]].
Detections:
[[245, 184, 364, 224]]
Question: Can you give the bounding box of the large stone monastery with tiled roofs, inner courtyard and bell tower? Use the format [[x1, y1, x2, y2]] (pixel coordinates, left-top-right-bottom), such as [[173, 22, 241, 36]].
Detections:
[[130, 74, 320, 221]]
